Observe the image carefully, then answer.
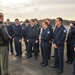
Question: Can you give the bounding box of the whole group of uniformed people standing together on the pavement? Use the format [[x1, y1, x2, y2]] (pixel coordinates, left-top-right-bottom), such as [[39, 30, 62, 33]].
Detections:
[[0, 13, 75, 75]]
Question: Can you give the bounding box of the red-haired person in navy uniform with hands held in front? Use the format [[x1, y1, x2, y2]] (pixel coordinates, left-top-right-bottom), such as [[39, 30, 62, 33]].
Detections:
[[39, 21, 51, 67]]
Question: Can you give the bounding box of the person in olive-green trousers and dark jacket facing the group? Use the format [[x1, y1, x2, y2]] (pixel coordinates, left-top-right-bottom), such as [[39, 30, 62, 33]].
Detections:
[[0, 12, 11, 75]]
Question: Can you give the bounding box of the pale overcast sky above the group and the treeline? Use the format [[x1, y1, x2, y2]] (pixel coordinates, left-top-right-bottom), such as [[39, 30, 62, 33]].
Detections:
[[0, 0, 75, 21]]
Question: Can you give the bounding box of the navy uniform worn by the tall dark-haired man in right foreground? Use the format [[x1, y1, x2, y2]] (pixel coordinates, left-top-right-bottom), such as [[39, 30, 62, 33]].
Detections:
[[53, 25, 67, 71]]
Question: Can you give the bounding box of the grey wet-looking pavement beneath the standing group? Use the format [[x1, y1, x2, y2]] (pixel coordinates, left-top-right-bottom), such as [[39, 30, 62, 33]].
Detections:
[[9, 45, 73, 75]]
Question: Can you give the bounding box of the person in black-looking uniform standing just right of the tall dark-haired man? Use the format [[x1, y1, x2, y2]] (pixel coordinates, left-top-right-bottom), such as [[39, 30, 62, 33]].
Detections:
[[68, 23, 75, 64]]
